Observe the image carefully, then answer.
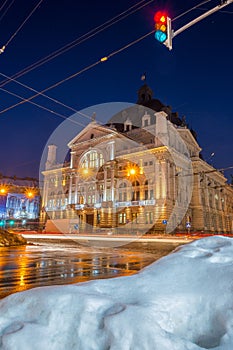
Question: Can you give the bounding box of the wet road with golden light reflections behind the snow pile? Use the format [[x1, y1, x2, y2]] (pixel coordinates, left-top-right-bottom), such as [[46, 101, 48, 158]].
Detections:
[[0, 245, 180, 298]]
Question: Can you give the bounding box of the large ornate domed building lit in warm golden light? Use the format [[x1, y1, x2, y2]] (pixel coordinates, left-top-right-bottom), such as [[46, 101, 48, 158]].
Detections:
[[42, 84, 233, 233]]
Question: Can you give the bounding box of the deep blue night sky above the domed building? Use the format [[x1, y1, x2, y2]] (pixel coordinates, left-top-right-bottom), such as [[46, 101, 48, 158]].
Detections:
[[0, 0, 233, 177]]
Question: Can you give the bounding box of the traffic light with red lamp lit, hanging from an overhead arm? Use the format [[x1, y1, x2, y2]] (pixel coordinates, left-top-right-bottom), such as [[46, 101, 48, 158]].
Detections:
[[154, 11, 172, 50]]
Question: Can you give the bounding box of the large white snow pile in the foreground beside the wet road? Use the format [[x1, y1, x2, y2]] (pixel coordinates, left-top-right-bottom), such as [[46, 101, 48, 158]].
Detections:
[[0, 237, 233, 350]]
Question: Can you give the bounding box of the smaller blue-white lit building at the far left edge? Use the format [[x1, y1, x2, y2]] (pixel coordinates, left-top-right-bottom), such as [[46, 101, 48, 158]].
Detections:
[[0, 174, 40, 227]]
